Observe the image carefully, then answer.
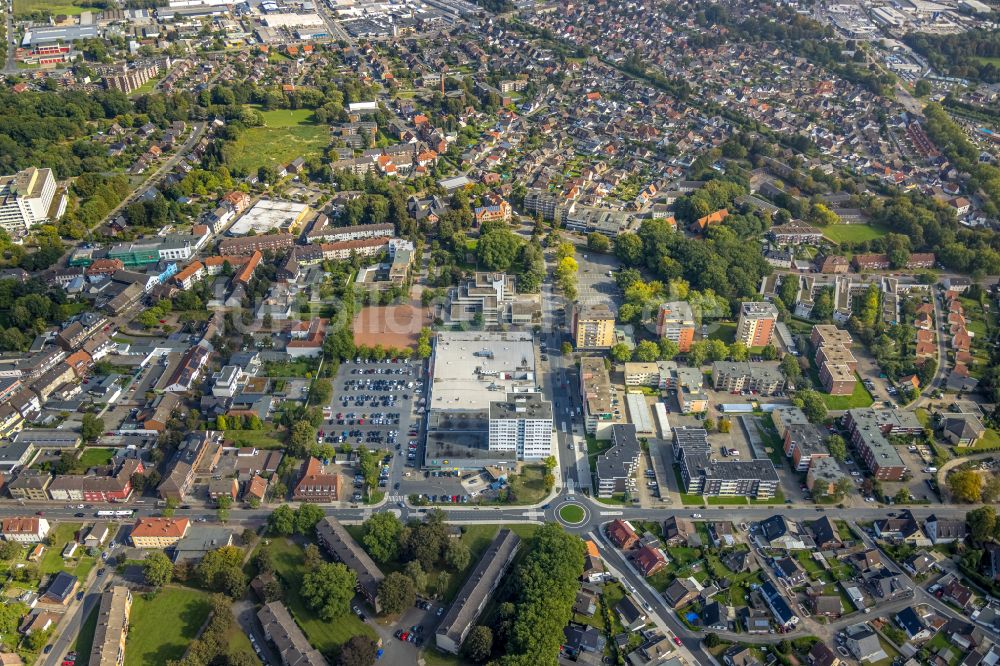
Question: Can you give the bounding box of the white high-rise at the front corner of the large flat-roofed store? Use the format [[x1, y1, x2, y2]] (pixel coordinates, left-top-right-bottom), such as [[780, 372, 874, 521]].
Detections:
[[489, 393, 552, 460]]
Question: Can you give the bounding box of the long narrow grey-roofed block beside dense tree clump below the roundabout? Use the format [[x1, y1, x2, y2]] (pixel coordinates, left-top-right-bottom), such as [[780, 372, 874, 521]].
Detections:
[[434, 528, 521, 654]]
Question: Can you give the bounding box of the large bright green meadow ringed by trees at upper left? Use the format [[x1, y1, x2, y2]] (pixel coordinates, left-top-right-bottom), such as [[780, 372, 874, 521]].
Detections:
[[226, 109, 330, 173]]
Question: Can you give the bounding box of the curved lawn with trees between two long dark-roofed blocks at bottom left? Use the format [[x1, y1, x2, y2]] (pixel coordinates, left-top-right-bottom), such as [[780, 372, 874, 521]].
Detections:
[[256, 539, 375, 653]]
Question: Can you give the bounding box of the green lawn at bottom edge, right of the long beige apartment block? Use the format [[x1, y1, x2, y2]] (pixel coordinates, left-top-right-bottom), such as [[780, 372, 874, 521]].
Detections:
[[125, 586, 211, 666]]
